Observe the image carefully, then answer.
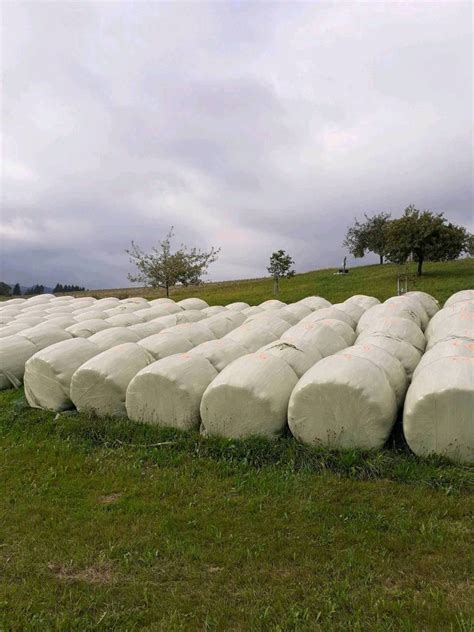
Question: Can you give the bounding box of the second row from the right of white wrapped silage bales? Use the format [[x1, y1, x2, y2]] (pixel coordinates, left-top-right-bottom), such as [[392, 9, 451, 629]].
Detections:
[[288, 292, 438, 449]]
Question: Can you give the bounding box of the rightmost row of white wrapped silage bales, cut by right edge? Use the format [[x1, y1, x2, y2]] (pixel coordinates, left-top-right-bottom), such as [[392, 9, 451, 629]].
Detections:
[[403, 290, 474, 464]]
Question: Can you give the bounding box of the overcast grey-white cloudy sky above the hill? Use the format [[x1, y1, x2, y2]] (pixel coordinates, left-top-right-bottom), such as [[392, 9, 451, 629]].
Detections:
[[1, 1, 473, 288]]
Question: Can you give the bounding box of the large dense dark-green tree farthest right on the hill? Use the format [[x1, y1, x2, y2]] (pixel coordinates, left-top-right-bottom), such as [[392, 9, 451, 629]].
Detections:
[[386, 205, 472, 276]]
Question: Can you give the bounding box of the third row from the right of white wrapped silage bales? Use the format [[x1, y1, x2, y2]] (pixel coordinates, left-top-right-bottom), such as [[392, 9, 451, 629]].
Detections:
[[194, 297, 378, 438]]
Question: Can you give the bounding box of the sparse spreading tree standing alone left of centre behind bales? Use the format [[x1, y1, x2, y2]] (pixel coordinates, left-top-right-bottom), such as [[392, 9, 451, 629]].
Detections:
[[126, 227, 220, 296]]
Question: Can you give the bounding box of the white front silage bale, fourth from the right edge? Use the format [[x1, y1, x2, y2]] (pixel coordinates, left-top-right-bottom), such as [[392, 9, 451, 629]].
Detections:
[[126, 354, 217, 430]]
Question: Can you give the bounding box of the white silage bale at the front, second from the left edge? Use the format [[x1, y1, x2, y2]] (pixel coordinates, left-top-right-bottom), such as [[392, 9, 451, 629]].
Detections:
[[25, 338, 99, 411]]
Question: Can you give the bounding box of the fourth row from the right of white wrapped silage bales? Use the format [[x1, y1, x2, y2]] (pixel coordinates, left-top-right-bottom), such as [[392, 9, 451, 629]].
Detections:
[[126, 299, 314, 429]]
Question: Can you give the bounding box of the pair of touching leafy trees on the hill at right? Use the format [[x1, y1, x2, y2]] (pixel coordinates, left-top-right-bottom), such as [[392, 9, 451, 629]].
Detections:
[[343, 205, 474, 276]]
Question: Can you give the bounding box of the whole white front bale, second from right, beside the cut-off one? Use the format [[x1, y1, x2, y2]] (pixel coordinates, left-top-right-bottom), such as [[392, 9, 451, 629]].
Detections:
[[288, 354, 397, 450]]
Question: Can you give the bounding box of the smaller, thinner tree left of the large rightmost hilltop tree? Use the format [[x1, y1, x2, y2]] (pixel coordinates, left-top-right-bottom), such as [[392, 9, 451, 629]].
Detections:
[[342, 213, 390, 264]]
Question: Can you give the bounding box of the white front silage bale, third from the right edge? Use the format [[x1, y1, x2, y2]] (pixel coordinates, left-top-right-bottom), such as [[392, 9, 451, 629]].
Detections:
[[201, 353, 298, 439]]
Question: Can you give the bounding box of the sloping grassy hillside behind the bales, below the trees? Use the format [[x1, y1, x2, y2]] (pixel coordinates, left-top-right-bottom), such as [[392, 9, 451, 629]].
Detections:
[[58, 258, 474, 305]]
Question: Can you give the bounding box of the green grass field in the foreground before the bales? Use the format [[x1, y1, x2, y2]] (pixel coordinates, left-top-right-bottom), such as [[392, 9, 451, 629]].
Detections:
[[0, 391, 474, 632]]
